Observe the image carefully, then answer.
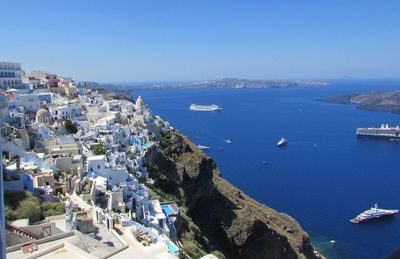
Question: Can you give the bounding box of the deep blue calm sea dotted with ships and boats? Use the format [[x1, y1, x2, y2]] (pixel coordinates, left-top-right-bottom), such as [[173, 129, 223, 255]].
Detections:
[[133, 80, 400, 258]]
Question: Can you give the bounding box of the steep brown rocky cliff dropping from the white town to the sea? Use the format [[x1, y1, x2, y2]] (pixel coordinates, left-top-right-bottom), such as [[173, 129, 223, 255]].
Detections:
[[151, 131, 316, 258]]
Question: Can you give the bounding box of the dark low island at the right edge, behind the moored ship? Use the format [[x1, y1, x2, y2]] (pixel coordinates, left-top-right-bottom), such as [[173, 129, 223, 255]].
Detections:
[[322, 90, 400, 113]]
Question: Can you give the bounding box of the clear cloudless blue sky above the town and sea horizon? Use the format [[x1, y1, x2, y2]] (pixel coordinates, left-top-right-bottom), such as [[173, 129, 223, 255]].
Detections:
[[0, 0, 400, 82]]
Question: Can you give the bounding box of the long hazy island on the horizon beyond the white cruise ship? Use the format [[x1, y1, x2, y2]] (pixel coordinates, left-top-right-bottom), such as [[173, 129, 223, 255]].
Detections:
[[96, 78, 328, 91]]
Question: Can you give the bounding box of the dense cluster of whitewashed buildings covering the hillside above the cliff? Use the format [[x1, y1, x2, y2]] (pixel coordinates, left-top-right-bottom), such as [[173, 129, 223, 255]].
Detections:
[[0, 62, 198, 258]]
